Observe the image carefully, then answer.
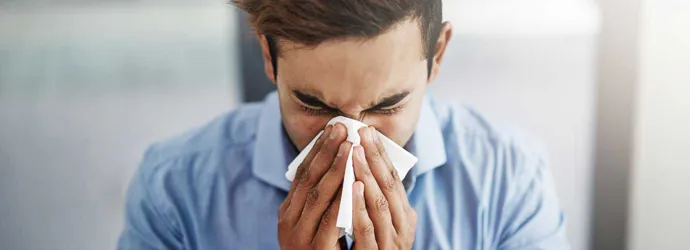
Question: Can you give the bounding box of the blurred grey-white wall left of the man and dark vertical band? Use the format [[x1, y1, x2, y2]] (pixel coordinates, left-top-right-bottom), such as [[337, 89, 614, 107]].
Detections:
[[0, 1, 238, 250]]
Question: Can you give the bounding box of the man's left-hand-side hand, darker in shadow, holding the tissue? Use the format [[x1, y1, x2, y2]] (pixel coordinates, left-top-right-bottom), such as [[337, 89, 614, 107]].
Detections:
[[278, 124, 352, 249]]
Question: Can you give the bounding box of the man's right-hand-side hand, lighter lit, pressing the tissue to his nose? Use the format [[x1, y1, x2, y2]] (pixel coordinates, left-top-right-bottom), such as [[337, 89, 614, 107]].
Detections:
[[352, 127, 417, 249]]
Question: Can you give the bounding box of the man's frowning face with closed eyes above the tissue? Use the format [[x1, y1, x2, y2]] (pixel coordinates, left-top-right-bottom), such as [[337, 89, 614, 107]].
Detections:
[[263, 21, 448, 150]]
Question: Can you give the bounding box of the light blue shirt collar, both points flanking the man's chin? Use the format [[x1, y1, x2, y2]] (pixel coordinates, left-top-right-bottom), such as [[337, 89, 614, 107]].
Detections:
[[252, 92, 446, 191]]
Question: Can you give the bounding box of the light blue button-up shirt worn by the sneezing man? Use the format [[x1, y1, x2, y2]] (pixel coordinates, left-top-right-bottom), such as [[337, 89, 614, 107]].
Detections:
[[118, 93, 570, 250]]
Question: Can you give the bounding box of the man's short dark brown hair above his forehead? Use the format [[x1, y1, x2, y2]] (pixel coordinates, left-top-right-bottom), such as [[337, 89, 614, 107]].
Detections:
[[232, 0, 442, 78]]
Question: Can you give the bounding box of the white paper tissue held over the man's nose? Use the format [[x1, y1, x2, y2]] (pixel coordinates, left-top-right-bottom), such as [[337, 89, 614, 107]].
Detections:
[[285, 116, 417, 239]]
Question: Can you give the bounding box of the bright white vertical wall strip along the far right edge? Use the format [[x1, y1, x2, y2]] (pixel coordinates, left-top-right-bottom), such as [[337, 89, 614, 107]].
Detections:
[[628, 0, 690, 250]]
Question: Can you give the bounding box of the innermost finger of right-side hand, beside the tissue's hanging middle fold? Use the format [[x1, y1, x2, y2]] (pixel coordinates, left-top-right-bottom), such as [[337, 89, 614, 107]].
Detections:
[[353, 146, 396, 246]]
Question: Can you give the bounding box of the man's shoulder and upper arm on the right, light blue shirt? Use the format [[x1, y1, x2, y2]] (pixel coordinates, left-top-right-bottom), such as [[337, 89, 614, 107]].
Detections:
[[438, 99, 569, 249]]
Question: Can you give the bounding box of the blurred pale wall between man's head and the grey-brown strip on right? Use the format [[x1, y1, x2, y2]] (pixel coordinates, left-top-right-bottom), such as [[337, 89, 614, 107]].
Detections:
[[431, 0, 599, 249]]
